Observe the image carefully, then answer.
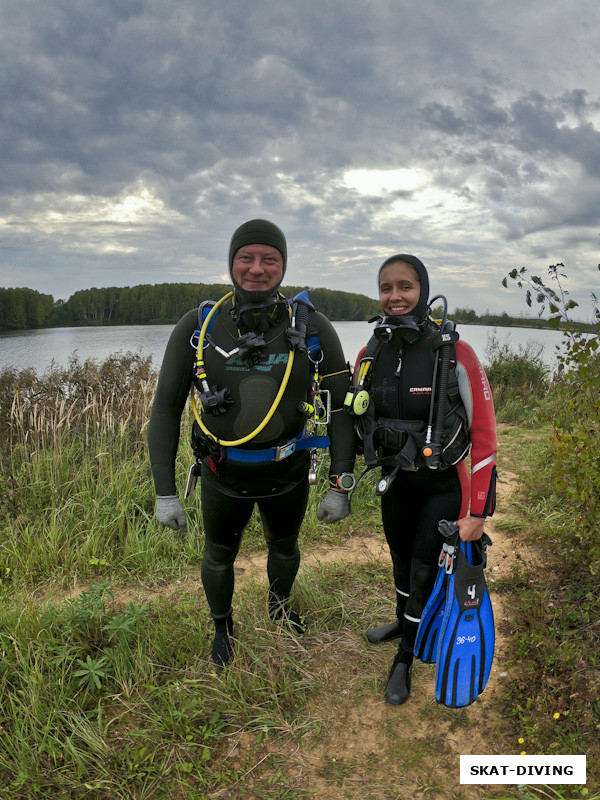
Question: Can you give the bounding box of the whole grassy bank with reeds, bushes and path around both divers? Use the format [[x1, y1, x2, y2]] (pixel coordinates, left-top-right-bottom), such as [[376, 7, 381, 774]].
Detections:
[[0, 310, 600, 800]]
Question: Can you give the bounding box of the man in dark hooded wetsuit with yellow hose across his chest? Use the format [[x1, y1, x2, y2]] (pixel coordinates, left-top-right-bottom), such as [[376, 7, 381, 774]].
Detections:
[[148, 219, 354, 666]]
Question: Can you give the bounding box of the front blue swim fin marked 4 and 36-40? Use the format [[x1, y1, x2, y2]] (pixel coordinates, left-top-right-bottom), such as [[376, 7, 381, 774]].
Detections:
[[435, 534, 495, 708]]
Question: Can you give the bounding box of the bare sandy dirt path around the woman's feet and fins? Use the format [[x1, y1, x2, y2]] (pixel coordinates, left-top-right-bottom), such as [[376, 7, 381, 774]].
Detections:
[[290, 470, 525, 800]]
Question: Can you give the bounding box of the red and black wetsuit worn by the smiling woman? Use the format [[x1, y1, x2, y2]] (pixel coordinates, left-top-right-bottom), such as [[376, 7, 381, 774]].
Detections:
[[355, 327, 496, 653]]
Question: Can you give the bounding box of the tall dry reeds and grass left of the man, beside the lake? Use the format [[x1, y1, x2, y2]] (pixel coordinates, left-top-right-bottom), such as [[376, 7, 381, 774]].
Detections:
[[0, 354, 204, 585]]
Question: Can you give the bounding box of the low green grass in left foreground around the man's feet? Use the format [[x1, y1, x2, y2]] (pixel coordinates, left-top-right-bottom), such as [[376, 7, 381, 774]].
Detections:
[[0, 565, 398, 798]]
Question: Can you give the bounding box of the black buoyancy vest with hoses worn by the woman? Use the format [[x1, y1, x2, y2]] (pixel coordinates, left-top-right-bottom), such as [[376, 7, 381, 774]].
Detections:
[[345, 297, 470, 494]]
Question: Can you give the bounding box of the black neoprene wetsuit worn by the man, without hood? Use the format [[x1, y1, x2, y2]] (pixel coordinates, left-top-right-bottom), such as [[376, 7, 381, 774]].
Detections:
[[148, 300, 354, 619]]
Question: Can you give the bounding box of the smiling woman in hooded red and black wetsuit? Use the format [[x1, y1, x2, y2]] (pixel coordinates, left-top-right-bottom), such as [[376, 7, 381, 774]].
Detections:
[[356, 255, 496, 705]]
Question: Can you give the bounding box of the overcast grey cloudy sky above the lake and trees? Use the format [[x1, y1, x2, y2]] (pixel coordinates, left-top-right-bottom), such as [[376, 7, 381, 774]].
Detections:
[[0, 0, 600, 318]]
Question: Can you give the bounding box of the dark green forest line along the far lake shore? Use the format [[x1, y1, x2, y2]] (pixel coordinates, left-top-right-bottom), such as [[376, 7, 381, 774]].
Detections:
[[0, 283, 594, 333]]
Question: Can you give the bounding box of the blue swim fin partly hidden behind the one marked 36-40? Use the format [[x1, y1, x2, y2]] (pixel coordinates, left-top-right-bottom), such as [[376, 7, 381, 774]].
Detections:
[[413, 520, 471, 664]]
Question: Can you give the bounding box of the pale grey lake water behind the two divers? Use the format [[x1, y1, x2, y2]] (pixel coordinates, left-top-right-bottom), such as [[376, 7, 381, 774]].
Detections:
[[0, 322, 562, 373]]
